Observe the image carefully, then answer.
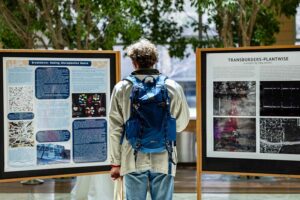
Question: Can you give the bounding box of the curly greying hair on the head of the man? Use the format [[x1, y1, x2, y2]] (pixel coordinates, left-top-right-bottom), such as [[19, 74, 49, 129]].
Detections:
[[126, 39, 158, 68]]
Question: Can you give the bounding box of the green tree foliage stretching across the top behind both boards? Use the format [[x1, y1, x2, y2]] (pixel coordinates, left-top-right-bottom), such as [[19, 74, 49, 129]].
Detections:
[[0, 0, 300, 55]]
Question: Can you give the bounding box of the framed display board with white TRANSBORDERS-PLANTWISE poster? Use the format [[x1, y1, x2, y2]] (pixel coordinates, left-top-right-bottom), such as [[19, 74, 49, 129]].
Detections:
[[197, 46, 300, 175]]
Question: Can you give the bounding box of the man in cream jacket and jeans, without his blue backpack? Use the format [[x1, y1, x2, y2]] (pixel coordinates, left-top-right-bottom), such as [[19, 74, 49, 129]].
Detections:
[[109, 40, 189, 200]]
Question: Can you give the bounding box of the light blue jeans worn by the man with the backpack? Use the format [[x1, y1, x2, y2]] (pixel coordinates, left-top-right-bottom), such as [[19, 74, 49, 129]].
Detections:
[[125, 170, 174, 200]]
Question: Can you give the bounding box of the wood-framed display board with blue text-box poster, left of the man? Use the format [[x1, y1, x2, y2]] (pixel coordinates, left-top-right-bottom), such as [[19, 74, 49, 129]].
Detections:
[[0, 50, 120, 182]]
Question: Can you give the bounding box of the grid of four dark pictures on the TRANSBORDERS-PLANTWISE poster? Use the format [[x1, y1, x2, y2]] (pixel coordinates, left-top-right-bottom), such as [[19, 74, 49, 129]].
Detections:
[[213, 81, 300, 154]]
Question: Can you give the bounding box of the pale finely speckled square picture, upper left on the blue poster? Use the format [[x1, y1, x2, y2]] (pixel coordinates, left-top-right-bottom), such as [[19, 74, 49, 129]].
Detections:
[[8, 86, 33, 112]]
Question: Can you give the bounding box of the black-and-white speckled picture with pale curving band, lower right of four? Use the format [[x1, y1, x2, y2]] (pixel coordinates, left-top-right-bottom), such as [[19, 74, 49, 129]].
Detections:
[[260, 118, 300, 154]]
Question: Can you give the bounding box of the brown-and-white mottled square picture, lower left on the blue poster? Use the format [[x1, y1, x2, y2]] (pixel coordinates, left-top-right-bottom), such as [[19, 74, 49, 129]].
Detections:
[[8, 121, 34, 148]]
